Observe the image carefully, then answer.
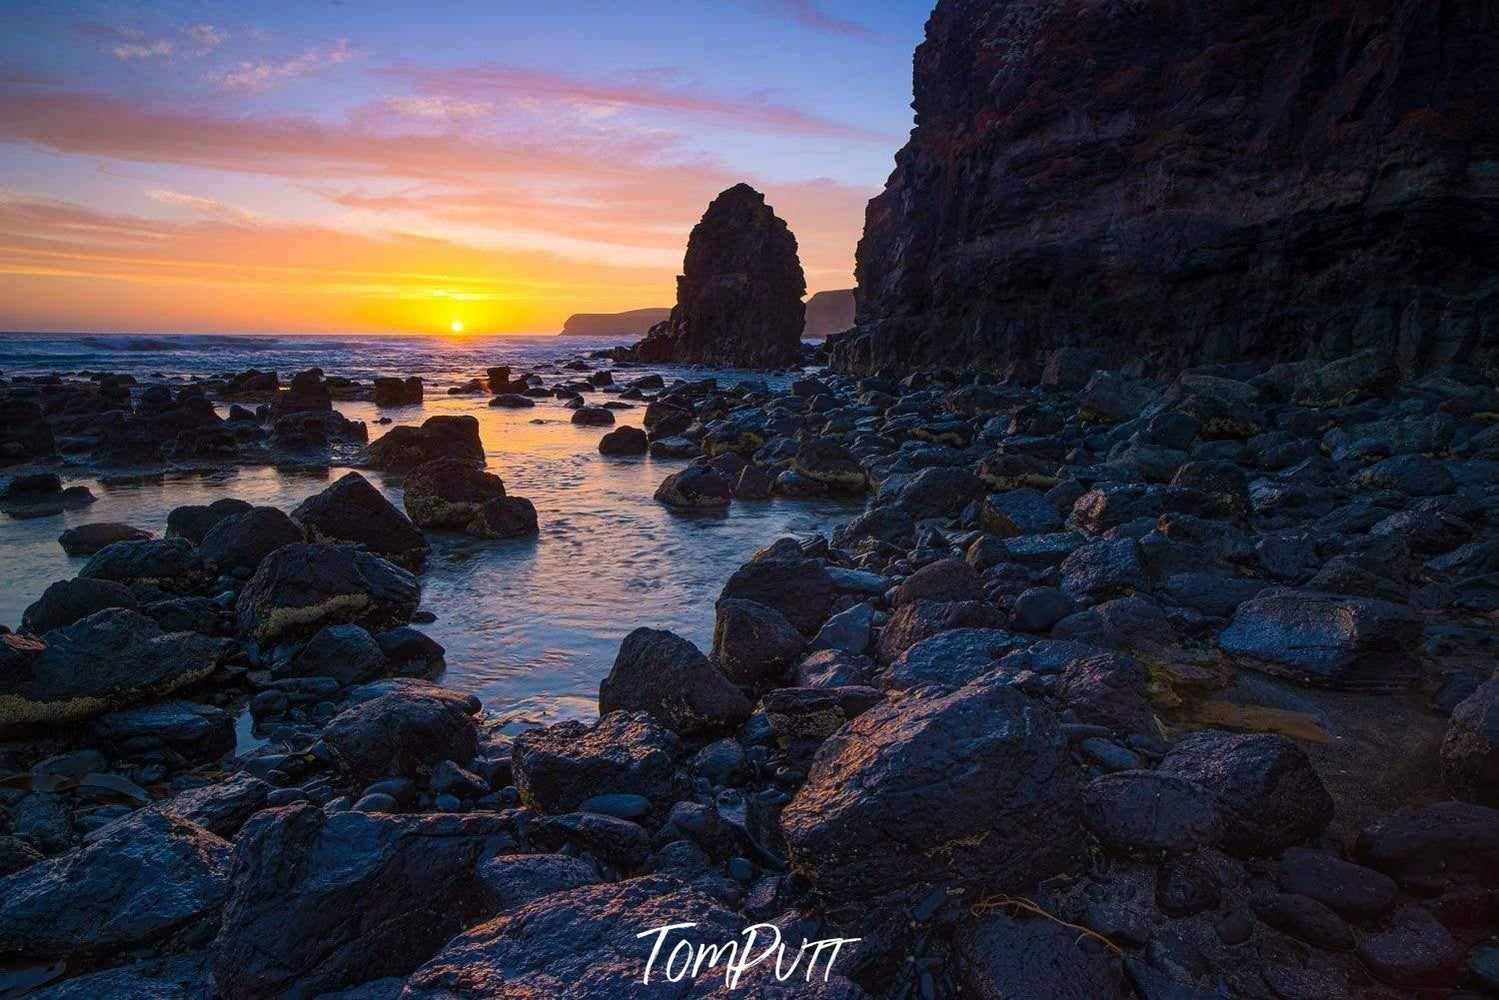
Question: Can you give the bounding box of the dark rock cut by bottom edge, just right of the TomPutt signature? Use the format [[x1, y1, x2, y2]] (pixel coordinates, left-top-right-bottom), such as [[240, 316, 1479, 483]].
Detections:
[[953, 913, 1130, 1000]]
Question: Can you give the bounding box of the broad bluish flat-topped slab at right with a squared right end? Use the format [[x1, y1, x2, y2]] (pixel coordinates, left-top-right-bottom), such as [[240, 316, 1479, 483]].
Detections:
[[1219, 588, 1421, 691]]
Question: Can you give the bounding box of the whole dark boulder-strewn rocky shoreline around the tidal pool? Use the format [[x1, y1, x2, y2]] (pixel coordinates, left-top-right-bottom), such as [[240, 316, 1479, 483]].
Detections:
[[0, 341, 1499, 1000]]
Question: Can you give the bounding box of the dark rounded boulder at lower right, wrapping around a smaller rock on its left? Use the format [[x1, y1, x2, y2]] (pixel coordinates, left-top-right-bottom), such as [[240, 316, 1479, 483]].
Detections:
[[1160, 730, 1333, 855]]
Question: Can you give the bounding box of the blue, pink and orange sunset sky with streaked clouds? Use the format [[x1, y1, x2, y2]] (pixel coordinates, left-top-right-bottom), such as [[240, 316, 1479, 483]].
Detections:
[[0, 0, 931, 333]]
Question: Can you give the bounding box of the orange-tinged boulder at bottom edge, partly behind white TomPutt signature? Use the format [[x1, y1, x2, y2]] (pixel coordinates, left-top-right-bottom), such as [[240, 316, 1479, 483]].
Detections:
[[402, 876, 743, 1000]]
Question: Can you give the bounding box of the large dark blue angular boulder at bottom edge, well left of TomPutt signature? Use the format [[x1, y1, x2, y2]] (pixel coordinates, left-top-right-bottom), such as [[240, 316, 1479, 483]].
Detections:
[[213, 802, 513, 1000]]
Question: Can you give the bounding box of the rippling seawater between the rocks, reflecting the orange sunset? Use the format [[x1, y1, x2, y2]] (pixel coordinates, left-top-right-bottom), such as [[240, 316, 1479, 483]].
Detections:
[[0, 337, 854, 727]]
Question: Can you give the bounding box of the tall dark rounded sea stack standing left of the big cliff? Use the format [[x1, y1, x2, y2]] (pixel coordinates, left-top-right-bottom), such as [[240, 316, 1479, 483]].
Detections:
[[634, 184, 806, 369]]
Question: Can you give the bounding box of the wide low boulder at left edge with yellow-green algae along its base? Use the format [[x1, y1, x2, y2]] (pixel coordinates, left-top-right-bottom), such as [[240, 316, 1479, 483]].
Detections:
[[0, 607, 220, 727]]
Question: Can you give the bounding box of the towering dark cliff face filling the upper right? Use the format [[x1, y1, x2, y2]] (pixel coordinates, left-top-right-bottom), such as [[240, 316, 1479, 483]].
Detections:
[[833, 0, 1499, 372]]
